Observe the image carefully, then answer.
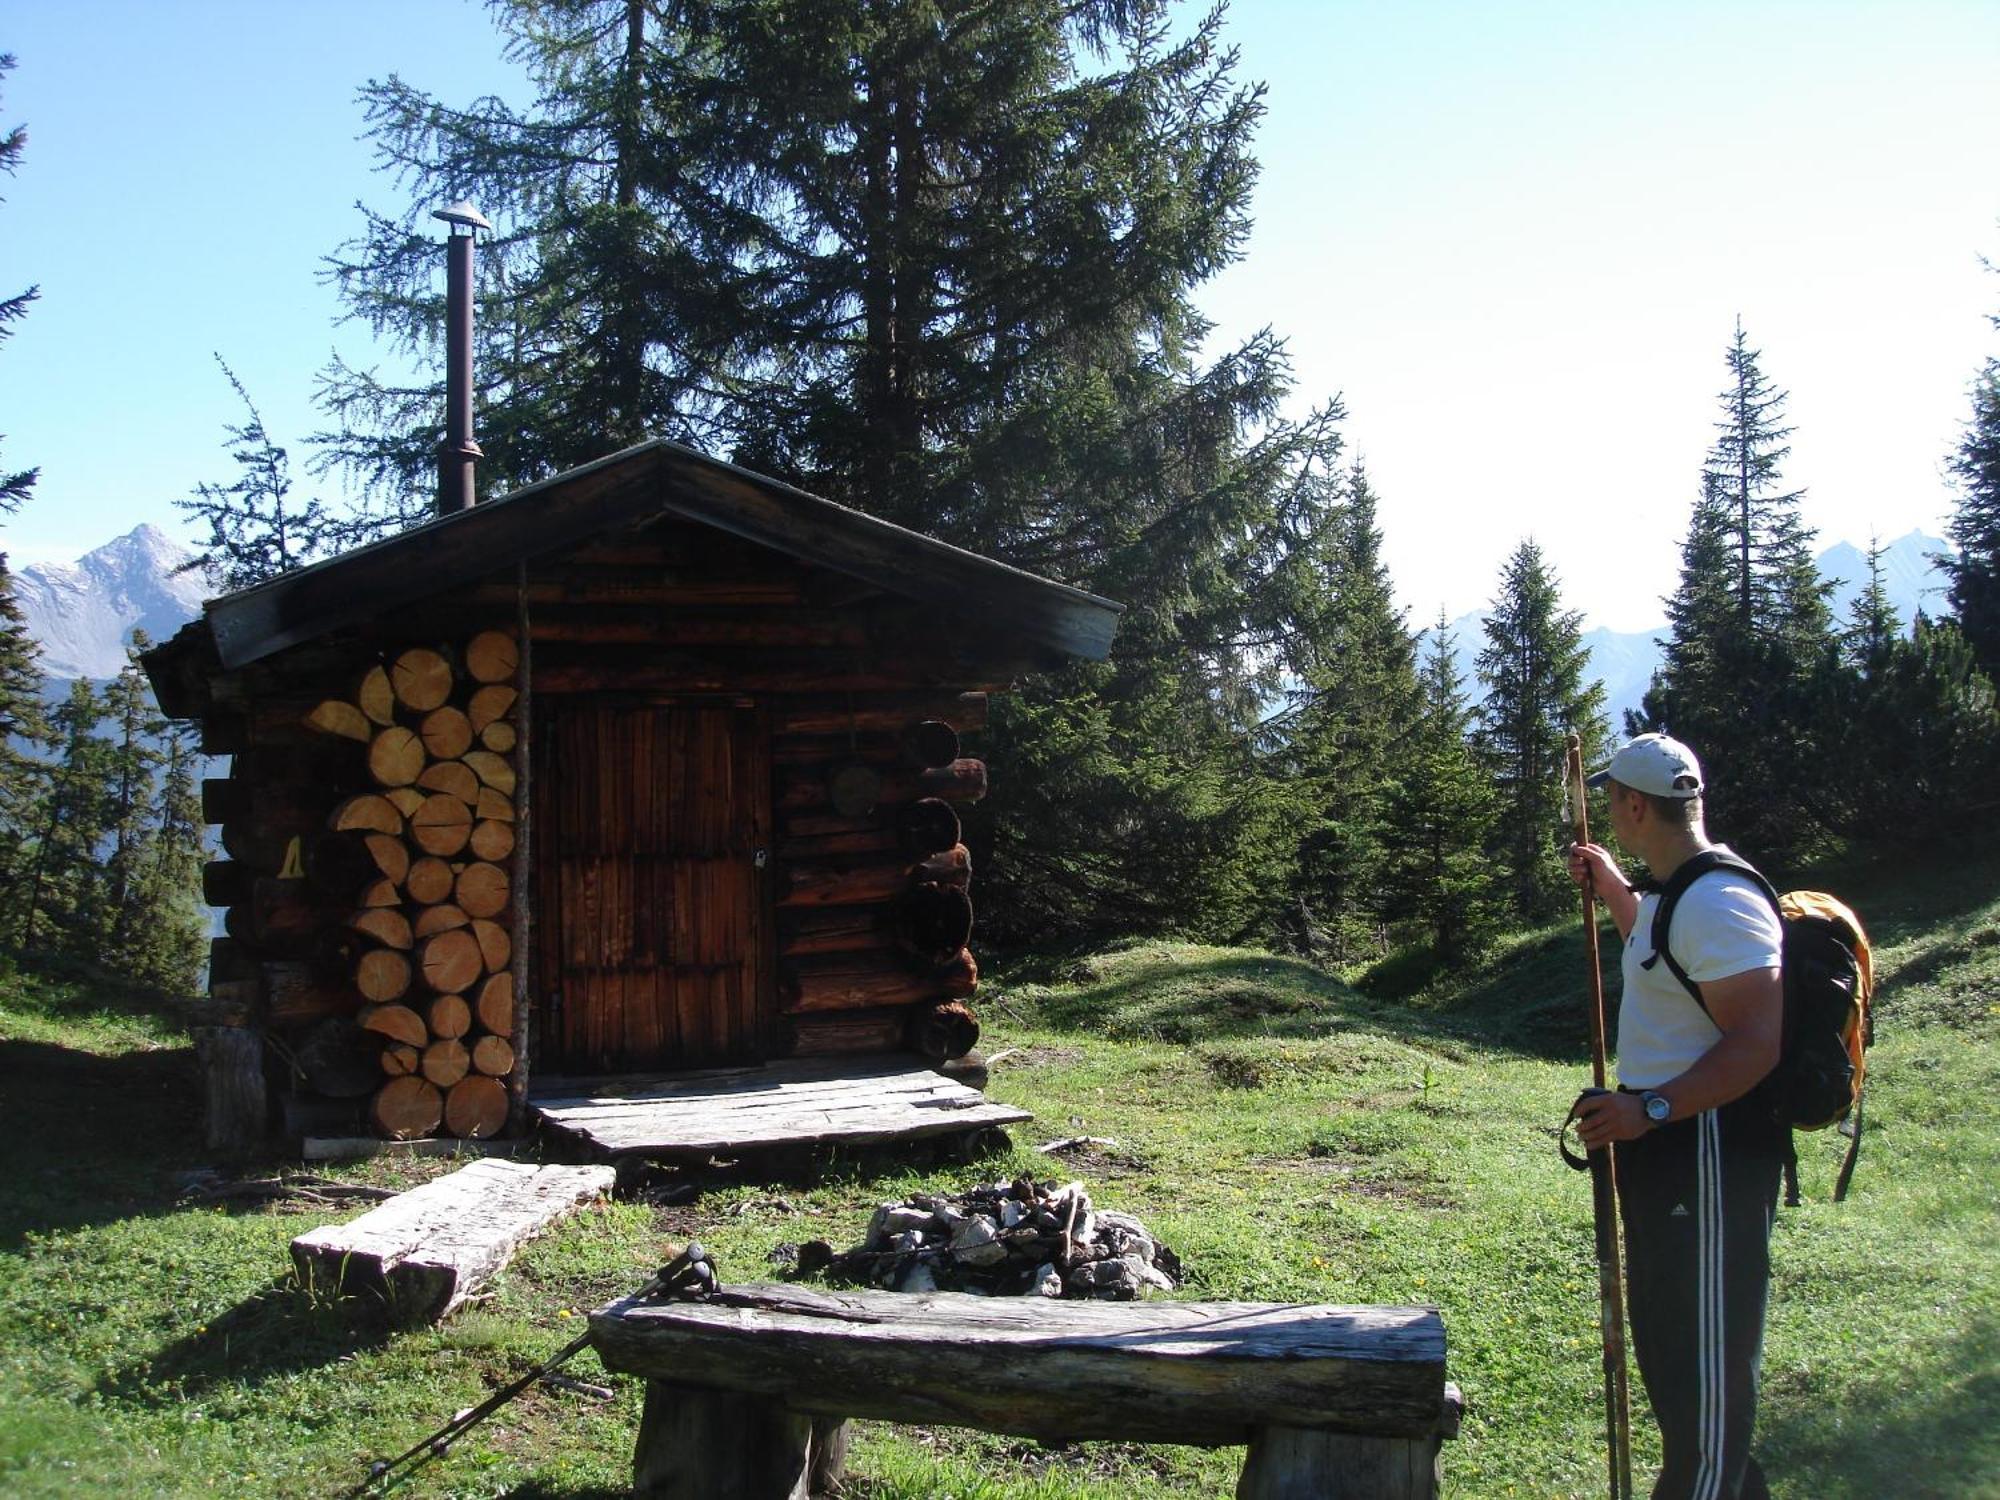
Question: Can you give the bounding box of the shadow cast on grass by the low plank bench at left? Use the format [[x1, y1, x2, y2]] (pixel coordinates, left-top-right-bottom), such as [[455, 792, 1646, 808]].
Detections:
[[96, 1276, 406, 1408]]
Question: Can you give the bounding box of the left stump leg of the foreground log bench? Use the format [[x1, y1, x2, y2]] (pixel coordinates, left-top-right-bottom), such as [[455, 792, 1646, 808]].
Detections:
[[632, 1380, 814, 1500]]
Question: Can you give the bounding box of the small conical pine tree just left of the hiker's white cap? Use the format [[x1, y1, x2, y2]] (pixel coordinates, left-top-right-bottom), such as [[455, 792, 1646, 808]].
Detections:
[[1478, 540, 1604, 922]]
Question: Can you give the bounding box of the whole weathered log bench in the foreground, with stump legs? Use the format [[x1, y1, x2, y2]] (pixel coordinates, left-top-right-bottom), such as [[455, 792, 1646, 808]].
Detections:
[[590, 1284, 1460, 1500]]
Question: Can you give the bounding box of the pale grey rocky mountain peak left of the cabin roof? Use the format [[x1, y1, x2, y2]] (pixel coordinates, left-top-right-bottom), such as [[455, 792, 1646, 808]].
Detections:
[[14, 526, 210, 678]]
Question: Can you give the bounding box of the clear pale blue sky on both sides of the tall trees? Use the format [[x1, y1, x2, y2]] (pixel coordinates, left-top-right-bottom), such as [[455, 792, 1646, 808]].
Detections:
[[0, 0, 2000, 630]]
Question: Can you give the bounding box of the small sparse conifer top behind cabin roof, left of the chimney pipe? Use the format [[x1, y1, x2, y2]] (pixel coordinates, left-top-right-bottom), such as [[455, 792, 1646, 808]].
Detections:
[[174, 354, 348, 590]]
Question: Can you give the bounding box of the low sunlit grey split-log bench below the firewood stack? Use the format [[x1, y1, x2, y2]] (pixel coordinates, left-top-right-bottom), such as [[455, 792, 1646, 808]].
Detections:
[[292, 1160, 616, 1322]]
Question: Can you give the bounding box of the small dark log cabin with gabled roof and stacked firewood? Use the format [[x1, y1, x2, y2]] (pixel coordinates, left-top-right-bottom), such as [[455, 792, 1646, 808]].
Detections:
[[144, 440, 1120, 1150]]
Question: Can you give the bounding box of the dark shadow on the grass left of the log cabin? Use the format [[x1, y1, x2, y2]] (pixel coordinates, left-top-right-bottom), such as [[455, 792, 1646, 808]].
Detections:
[[0, 1042, 202, 1250]]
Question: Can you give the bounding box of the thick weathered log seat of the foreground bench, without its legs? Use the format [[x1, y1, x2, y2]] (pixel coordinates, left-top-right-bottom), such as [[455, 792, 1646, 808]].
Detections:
[[590, 1284, 1444, 1444]]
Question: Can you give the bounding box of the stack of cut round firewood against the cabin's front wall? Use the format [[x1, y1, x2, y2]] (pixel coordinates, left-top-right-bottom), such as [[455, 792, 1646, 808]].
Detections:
[[306, 630, 520, 1140]]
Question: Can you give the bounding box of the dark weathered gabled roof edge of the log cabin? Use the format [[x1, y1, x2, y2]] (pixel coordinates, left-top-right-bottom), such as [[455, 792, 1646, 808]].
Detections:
[[148, 438, 1124, 712]]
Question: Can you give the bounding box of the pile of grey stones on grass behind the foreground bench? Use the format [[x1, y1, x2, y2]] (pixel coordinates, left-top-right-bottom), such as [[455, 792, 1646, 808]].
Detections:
[[800, 1178, 1180, 1302]]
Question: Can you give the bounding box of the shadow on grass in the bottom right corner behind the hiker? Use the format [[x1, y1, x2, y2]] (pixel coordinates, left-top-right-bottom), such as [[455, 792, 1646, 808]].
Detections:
[[1758, 1316, 2000, 1500]]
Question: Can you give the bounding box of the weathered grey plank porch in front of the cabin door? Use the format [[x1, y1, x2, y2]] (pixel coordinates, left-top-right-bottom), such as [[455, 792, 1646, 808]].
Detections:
[[528, 1054, 1034, 1160]]
